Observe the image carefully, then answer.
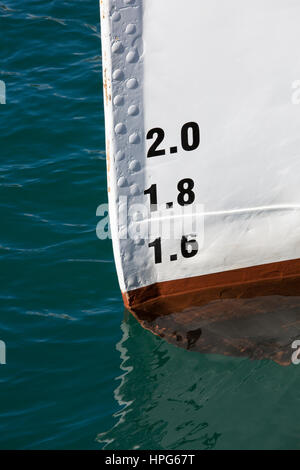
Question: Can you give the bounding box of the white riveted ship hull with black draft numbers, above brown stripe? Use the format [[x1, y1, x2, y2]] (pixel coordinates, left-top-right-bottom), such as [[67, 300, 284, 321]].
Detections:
[[101, 0, 300, 310]]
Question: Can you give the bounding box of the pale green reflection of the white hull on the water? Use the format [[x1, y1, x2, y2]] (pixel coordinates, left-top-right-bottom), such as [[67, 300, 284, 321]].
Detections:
[[97, 315, 300, 450]]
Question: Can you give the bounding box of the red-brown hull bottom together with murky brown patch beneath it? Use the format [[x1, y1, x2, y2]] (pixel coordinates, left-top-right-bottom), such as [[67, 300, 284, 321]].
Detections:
[[123, 260, 300, 365]]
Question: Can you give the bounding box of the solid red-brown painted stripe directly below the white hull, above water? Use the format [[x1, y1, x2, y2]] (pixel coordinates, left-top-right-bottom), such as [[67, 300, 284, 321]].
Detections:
[[123, 259, 300, 320]]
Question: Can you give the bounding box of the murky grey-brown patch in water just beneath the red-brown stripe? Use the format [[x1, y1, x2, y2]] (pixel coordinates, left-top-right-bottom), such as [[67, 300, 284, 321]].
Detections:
[[128, 294, 300, 365]]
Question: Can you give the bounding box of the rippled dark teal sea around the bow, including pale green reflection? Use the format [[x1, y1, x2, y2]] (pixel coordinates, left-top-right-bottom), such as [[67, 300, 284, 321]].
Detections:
[[0, 0, 300, 449]]
